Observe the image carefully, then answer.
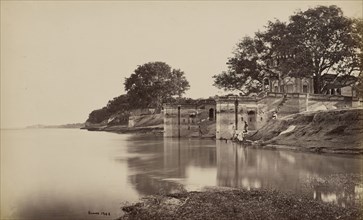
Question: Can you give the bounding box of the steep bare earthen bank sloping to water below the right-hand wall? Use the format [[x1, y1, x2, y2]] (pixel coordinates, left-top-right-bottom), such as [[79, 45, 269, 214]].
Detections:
[[247, 109, 363, 154]]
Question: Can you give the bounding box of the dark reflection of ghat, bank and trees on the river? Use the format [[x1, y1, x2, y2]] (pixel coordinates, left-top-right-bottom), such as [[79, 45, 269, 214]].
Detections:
[[128, 137, 363, 206]]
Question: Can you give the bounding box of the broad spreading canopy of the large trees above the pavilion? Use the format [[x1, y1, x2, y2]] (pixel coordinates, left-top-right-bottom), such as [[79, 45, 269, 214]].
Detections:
[[214, 6, 363, 94]]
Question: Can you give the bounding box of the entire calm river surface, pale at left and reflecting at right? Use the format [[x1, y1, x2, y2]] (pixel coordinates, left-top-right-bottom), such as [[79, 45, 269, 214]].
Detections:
[[1, 129, 363, 219]]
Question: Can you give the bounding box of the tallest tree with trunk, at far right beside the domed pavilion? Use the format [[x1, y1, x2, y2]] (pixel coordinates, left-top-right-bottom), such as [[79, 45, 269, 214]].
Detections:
[[288, 6, 361, 93]]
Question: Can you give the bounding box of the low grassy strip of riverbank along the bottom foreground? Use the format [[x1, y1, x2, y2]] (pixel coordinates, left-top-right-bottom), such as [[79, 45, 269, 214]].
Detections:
[[119, 188, 363, 220]]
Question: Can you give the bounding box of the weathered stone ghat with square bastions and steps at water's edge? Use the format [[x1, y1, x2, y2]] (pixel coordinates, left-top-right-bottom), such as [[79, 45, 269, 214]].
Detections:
[[164, 92, 363, 139]]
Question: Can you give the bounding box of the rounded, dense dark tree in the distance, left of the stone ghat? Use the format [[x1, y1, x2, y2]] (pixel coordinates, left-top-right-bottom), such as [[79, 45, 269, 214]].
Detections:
[[125, 62, 190, 109]]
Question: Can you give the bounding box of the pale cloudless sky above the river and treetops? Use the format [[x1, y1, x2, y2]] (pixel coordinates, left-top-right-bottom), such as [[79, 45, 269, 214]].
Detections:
[[0, 0, 363, 128]]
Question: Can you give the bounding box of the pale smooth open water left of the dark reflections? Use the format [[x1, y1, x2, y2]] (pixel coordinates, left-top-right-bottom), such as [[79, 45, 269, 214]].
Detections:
[[0, 129, 138, 220]]
